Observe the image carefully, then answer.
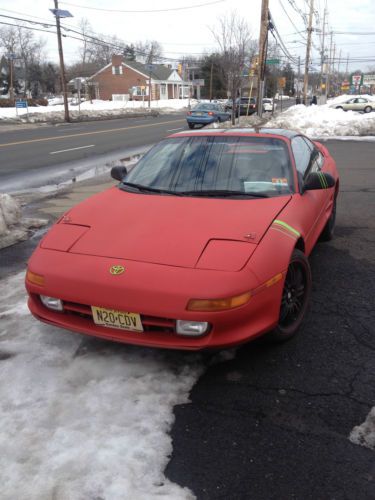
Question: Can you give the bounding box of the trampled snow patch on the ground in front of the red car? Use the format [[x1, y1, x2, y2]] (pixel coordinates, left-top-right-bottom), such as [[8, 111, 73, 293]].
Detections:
[[0, 273, 203, 500]]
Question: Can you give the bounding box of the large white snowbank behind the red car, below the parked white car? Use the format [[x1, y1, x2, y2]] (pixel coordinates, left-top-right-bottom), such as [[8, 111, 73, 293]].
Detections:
[[266, 104, 375, 138]]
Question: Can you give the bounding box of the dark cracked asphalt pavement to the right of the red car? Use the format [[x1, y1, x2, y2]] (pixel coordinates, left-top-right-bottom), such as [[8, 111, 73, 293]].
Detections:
[[166, 141, 375, 500]]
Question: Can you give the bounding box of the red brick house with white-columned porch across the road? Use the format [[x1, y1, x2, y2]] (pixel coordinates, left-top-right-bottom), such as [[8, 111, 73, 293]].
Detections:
[[88, 55, 191, 100]]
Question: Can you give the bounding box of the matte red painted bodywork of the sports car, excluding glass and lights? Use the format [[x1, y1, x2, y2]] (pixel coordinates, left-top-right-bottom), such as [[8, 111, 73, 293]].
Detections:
[[26, 132, 338, 350]]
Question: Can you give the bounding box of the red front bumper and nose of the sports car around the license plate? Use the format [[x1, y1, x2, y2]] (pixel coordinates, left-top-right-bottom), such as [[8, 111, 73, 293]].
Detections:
[[26, 249, 282, 350]]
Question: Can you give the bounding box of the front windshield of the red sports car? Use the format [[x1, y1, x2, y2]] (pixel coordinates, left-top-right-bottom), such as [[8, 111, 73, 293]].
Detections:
[[120, 136, 294, 197]]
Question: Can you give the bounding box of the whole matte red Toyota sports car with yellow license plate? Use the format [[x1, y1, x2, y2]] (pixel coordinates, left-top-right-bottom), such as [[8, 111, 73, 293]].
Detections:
[[26, 129, 339, 350]]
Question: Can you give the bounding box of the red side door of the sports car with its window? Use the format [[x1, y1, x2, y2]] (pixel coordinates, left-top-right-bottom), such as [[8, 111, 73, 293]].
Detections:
[[291, 136, 329, 253]]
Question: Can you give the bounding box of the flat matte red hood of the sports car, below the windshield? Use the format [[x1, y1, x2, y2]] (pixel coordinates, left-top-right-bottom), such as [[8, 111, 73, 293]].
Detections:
[[41, 188, 291, 270]]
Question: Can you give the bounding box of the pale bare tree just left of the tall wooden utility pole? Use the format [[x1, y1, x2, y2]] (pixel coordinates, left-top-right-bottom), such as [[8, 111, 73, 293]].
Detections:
[[211, 12, 251, 124]]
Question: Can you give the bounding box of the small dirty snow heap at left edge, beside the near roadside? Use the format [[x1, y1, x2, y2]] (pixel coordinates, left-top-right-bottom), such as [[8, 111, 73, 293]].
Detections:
[[0, 193, 48, 249]]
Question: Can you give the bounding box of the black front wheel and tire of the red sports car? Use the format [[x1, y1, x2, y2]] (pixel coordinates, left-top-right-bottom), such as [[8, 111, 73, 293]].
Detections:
[[267, 249, 312, 342]]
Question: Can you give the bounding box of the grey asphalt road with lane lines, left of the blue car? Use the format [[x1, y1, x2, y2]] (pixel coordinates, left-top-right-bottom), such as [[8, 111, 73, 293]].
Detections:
[[0, 113, 186, 178]]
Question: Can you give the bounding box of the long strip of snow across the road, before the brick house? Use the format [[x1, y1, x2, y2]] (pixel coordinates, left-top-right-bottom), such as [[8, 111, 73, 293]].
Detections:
[[0, 99, 197, 123]]
